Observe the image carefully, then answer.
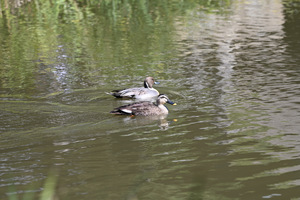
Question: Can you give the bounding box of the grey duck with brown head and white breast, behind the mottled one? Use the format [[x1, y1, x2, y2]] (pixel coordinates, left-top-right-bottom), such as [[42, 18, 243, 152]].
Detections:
[[110, 77, 159, 100]]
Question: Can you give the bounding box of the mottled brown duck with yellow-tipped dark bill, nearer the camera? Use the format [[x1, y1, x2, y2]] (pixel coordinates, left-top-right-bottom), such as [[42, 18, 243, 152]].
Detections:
[[110, 94, 176, 116]]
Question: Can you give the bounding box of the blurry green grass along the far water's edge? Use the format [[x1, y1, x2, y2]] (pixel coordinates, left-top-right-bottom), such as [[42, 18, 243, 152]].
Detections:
[[0, 0, 230, 29]]
